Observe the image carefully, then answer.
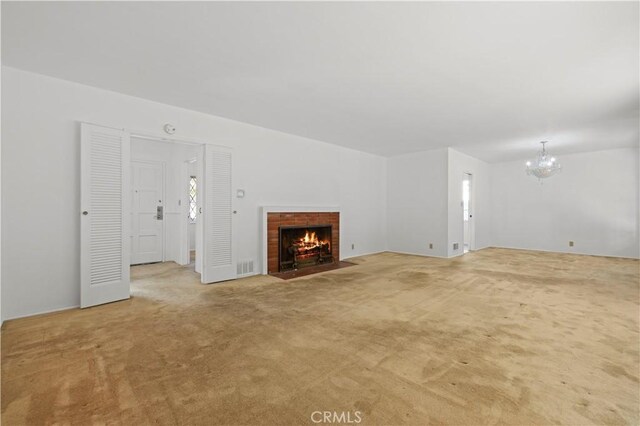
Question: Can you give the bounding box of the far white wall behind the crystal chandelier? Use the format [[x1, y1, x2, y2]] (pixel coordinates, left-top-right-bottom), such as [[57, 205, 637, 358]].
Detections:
[[491, 149, 639, 258]]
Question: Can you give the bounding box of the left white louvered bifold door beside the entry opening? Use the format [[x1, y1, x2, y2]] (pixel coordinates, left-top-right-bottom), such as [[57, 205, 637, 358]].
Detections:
[[80, 123, 131, 308]]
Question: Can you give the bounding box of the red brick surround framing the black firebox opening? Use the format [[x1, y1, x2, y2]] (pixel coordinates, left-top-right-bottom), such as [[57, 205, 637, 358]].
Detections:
[[267, 212, 340, 274]]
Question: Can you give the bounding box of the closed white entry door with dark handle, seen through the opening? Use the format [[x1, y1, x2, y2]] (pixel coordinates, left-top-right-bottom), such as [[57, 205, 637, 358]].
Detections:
[[131, 160, 164, 265]]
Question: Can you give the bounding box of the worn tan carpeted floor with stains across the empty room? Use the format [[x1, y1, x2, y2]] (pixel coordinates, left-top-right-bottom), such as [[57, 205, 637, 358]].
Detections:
[[2, 249, 640, 425]]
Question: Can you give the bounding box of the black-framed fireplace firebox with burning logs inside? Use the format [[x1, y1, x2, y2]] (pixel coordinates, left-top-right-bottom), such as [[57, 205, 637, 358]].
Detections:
[[278, 225, 333, 272]]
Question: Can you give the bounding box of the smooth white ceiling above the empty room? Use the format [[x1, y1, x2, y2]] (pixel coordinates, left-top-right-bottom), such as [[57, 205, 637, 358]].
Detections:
[[2, 1, 640, 161]]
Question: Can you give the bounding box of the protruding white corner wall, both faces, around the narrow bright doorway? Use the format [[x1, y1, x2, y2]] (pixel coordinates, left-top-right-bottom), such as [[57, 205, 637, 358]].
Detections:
[[387, 148, 491, 257]]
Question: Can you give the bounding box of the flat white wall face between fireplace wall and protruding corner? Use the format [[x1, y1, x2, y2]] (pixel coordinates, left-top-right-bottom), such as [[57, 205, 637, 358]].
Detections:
[[387, 148, 448, 257]]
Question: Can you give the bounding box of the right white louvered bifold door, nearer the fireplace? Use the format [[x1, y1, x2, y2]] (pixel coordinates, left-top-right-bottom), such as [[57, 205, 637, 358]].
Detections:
[[200, 145, 236, 283]]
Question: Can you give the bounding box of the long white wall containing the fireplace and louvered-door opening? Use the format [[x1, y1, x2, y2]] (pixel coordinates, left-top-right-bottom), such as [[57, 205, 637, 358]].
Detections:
[[2, 67, 387, 319]]
